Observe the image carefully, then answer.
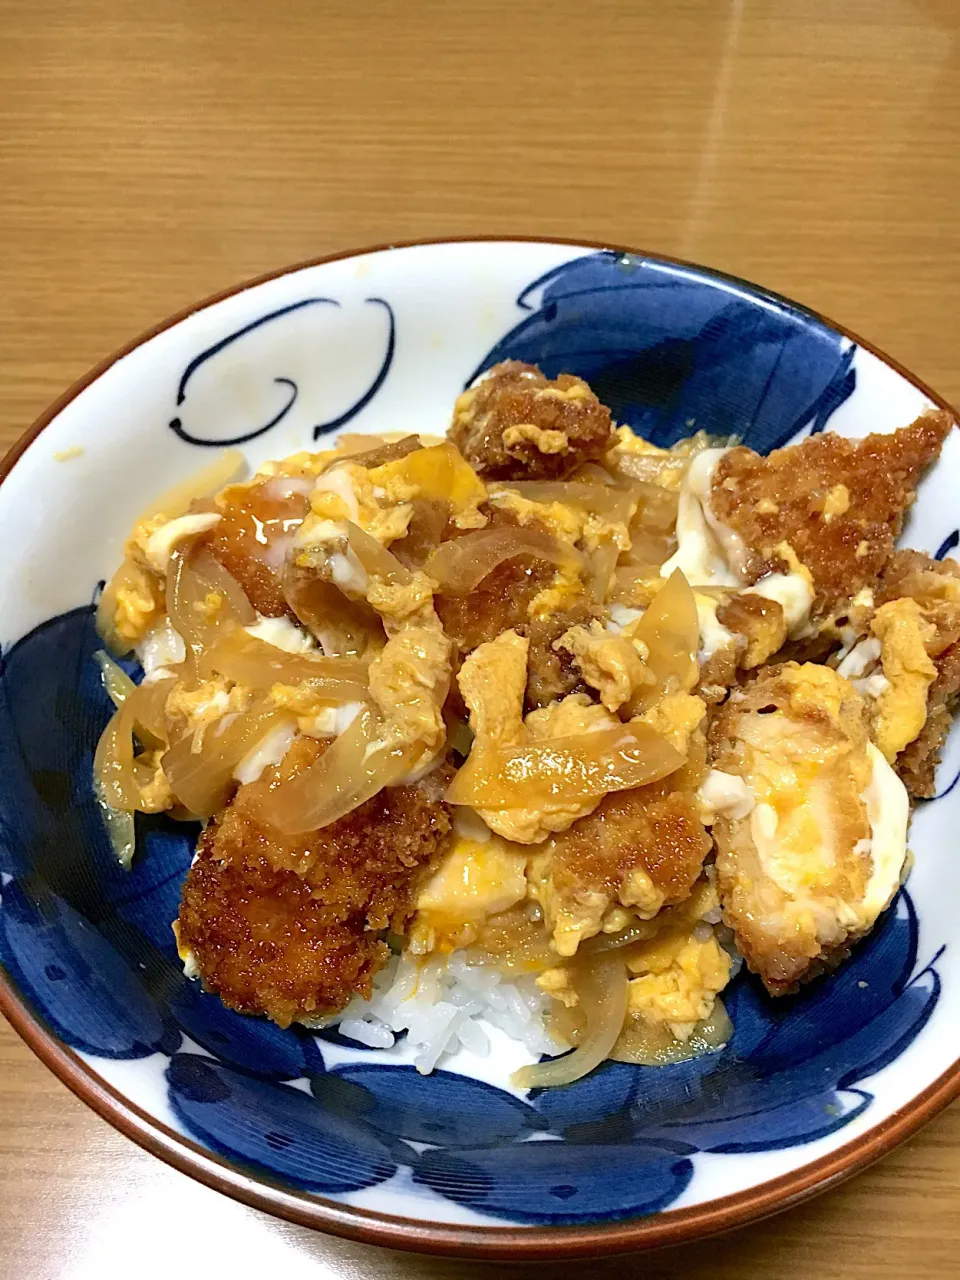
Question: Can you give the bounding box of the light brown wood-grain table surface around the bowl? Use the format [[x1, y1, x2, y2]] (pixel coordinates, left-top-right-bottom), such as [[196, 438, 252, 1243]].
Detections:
[[0, 0, 960, 1280]]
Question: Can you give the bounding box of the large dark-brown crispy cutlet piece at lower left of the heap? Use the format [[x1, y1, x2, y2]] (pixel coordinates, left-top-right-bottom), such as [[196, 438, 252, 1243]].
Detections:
[[178, 737, 451, 1027]]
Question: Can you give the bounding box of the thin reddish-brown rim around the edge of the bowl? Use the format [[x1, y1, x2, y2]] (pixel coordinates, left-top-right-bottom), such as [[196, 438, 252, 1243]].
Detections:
[[0, 236, 960, 1262]]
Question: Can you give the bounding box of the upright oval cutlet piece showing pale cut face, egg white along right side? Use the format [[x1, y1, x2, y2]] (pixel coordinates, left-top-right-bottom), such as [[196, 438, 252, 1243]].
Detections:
[[707, 663, 909, 995]]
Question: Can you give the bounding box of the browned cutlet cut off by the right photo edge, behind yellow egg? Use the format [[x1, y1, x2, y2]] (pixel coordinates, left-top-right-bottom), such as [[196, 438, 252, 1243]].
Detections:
[[876, 550, 960, 799]]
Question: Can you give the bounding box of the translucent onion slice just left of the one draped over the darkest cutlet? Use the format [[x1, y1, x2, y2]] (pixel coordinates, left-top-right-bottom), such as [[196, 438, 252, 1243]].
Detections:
[[163, 704, 289, 818]]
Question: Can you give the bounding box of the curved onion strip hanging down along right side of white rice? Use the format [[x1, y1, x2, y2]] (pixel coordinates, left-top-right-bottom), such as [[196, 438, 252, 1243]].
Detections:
[[511, 955, 627, 1089]]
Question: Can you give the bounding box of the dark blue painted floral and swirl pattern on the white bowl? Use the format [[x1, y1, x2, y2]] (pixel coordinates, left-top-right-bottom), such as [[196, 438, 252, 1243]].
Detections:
[[0, 244, 955, 1225]]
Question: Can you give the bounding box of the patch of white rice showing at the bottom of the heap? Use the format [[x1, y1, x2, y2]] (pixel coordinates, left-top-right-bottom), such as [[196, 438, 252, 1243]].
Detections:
[[325, 952, 563, 1075]]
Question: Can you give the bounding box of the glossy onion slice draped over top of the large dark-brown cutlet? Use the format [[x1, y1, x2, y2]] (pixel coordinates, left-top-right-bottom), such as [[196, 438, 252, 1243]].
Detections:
[[261, 707, 415, 836]]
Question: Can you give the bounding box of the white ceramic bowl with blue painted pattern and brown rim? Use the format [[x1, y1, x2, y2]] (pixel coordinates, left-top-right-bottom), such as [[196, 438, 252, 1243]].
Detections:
[[0, 241, 960, 1258]]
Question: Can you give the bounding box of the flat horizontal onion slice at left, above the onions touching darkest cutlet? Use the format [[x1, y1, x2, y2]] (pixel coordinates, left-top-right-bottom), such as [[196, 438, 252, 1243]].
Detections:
[[200, 627, 367, 703]]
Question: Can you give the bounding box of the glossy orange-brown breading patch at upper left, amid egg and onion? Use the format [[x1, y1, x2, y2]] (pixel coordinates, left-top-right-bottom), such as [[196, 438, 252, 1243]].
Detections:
[[202, 480, 308, 618]]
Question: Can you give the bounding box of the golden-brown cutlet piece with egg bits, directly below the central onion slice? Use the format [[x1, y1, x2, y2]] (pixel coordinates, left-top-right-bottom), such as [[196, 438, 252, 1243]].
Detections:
[[532, 752, 710, 955]]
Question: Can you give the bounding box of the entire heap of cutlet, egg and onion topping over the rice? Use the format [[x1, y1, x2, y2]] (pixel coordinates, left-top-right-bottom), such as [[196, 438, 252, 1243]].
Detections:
[[96, 362, 960, 1083]]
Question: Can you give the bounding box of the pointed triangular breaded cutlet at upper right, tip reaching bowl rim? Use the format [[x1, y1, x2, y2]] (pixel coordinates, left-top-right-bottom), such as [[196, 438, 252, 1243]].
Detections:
[[710, 411, 954, 617]]
